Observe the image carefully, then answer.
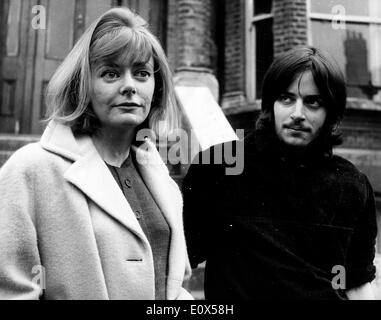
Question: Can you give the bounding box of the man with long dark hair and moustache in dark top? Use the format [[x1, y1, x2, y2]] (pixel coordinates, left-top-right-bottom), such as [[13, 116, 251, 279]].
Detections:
[[183, 47, 377, 300]]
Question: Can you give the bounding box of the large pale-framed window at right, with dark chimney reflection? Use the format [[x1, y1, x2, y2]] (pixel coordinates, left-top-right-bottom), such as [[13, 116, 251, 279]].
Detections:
[[308, 0, 381, 102]]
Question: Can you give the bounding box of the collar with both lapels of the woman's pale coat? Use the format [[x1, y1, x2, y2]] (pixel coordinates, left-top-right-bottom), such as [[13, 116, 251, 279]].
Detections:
[[40, 121, 182, 251]]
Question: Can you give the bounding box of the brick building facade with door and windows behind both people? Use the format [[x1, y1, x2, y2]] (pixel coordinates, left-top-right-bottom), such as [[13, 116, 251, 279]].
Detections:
[[0, 0, 381, 298]]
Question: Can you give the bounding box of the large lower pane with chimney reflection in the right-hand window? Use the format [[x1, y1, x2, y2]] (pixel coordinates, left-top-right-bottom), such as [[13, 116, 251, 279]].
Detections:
[[311, 21, 381, 101]]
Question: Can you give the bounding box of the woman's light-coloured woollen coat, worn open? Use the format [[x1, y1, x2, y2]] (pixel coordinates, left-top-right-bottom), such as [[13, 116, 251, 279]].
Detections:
[[0, 122, 192, 300]]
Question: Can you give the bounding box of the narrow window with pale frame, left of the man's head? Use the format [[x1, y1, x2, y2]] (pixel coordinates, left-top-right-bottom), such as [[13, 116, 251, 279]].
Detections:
[[245, 0, 274, 102]]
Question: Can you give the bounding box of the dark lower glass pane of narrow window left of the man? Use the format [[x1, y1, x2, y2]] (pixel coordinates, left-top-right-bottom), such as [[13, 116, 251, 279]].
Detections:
[[255, 19, 273, 98]]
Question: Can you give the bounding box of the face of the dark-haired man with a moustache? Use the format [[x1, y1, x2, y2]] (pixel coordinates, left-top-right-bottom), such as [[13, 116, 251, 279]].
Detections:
[[274, 71, 327, 147]]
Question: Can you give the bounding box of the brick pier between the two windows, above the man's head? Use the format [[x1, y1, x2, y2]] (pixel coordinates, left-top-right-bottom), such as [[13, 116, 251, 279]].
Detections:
[[273, 0, 307, 56]]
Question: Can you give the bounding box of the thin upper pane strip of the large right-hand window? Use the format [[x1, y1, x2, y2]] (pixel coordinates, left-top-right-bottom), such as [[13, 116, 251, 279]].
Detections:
[[310, 0, 368, 16]]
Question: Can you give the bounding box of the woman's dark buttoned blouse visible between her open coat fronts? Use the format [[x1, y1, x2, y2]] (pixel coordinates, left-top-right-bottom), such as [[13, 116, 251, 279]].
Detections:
[[106, 156, 171, 300]]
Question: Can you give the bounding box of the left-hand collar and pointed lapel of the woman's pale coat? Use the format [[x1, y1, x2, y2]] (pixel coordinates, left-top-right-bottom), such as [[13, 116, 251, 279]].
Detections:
[[41, 121, 148, 244]]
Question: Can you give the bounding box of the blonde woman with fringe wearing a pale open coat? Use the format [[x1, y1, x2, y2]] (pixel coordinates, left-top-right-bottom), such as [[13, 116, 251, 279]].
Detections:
[[0, 8, 191, 299]]
